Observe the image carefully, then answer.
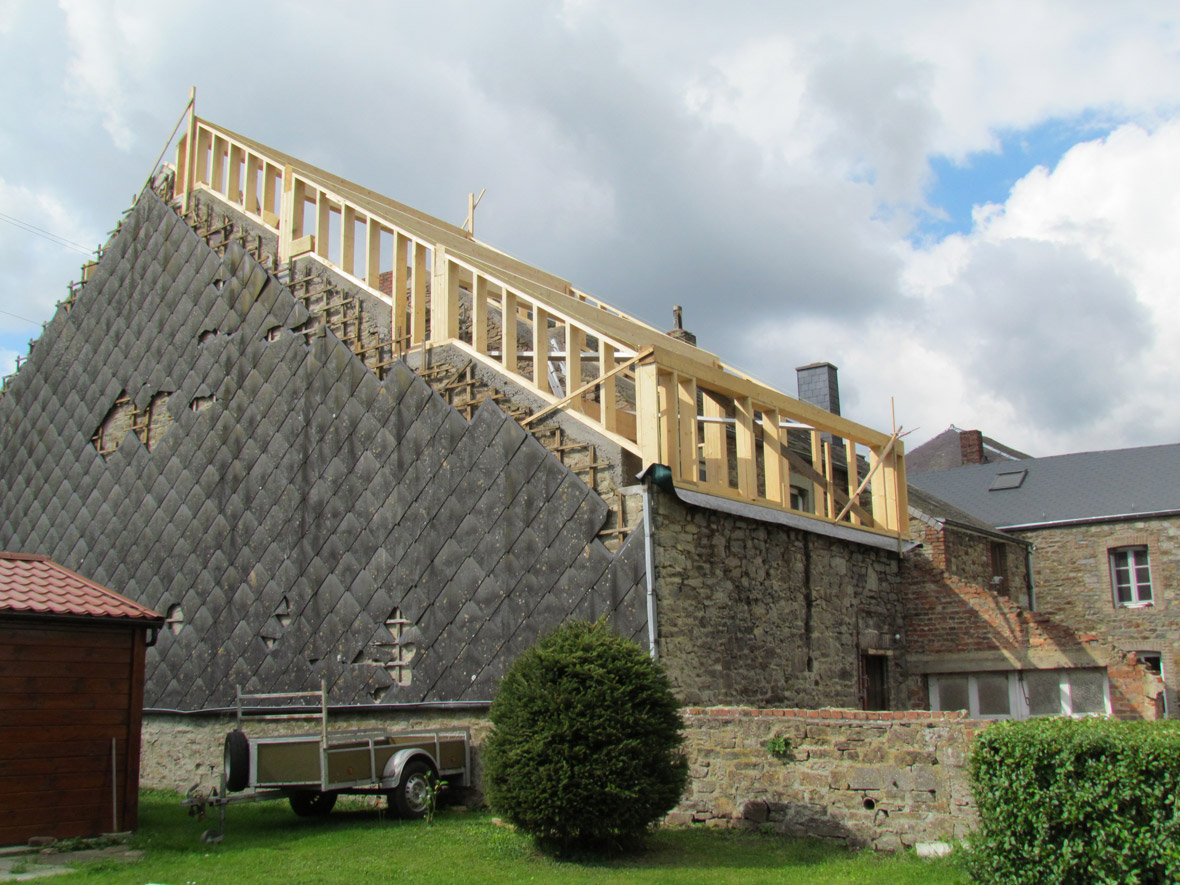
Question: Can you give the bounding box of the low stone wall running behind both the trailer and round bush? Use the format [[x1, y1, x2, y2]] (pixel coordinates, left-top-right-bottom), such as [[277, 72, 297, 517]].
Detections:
[[140, 707, 986, 850]]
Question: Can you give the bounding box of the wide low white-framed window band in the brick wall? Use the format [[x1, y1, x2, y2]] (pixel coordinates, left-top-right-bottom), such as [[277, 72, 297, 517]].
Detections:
[[930, 668, 1110, 719]]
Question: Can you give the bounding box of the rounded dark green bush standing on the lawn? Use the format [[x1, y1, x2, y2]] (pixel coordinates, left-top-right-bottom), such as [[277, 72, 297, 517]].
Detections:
[[483, 621, 688, 851]]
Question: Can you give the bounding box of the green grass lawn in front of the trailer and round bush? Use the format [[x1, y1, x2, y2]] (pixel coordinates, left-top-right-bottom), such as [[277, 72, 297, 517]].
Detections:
[[53, 793, 966, 885]]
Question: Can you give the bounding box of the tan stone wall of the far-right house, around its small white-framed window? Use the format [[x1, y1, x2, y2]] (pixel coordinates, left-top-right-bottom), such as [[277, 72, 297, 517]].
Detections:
[[1021, 517, 1180, 716]]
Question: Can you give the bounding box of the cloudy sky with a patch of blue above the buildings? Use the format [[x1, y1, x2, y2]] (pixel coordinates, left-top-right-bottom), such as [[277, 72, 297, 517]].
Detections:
[[0, 0, 1180, 455]]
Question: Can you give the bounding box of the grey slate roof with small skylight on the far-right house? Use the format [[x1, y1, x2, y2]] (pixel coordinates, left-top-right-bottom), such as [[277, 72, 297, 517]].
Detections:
[[909, 444, 1180, 529]]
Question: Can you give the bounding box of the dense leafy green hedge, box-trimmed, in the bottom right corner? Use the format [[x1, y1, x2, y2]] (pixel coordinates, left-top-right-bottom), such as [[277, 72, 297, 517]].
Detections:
[[969, 719, 1180, 885]]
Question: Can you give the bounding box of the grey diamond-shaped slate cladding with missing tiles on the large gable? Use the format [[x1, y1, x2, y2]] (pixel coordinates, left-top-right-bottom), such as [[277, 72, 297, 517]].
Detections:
[[0, 191, 647, 710]]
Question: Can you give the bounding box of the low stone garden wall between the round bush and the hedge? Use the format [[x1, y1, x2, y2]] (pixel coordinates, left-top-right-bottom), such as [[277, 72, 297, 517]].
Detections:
[[668, 707, 988, 850]]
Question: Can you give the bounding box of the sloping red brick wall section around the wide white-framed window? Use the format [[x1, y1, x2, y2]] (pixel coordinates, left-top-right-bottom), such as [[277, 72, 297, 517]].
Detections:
[[904, 557, 1162, 719]]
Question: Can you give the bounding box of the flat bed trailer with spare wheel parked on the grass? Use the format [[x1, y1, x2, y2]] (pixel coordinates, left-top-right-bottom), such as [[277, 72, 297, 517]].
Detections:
[[183, 683, 471, 843]]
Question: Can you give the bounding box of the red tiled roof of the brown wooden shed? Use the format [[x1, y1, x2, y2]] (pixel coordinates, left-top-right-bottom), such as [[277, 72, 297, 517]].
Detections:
[[0, 552, 164, 621]]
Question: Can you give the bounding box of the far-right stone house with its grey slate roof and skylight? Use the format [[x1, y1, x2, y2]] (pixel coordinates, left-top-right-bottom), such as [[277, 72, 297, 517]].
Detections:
[[910, 445, 1180, 715]]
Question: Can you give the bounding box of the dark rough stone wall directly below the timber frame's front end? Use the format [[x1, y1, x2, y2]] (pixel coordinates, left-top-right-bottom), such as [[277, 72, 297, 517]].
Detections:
[[653, 491, 905, 708]]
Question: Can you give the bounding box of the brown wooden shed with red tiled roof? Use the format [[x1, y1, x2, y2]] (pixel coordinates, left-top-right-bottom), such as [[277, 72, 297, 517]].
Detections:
[[0, 552, 164, 845]]
